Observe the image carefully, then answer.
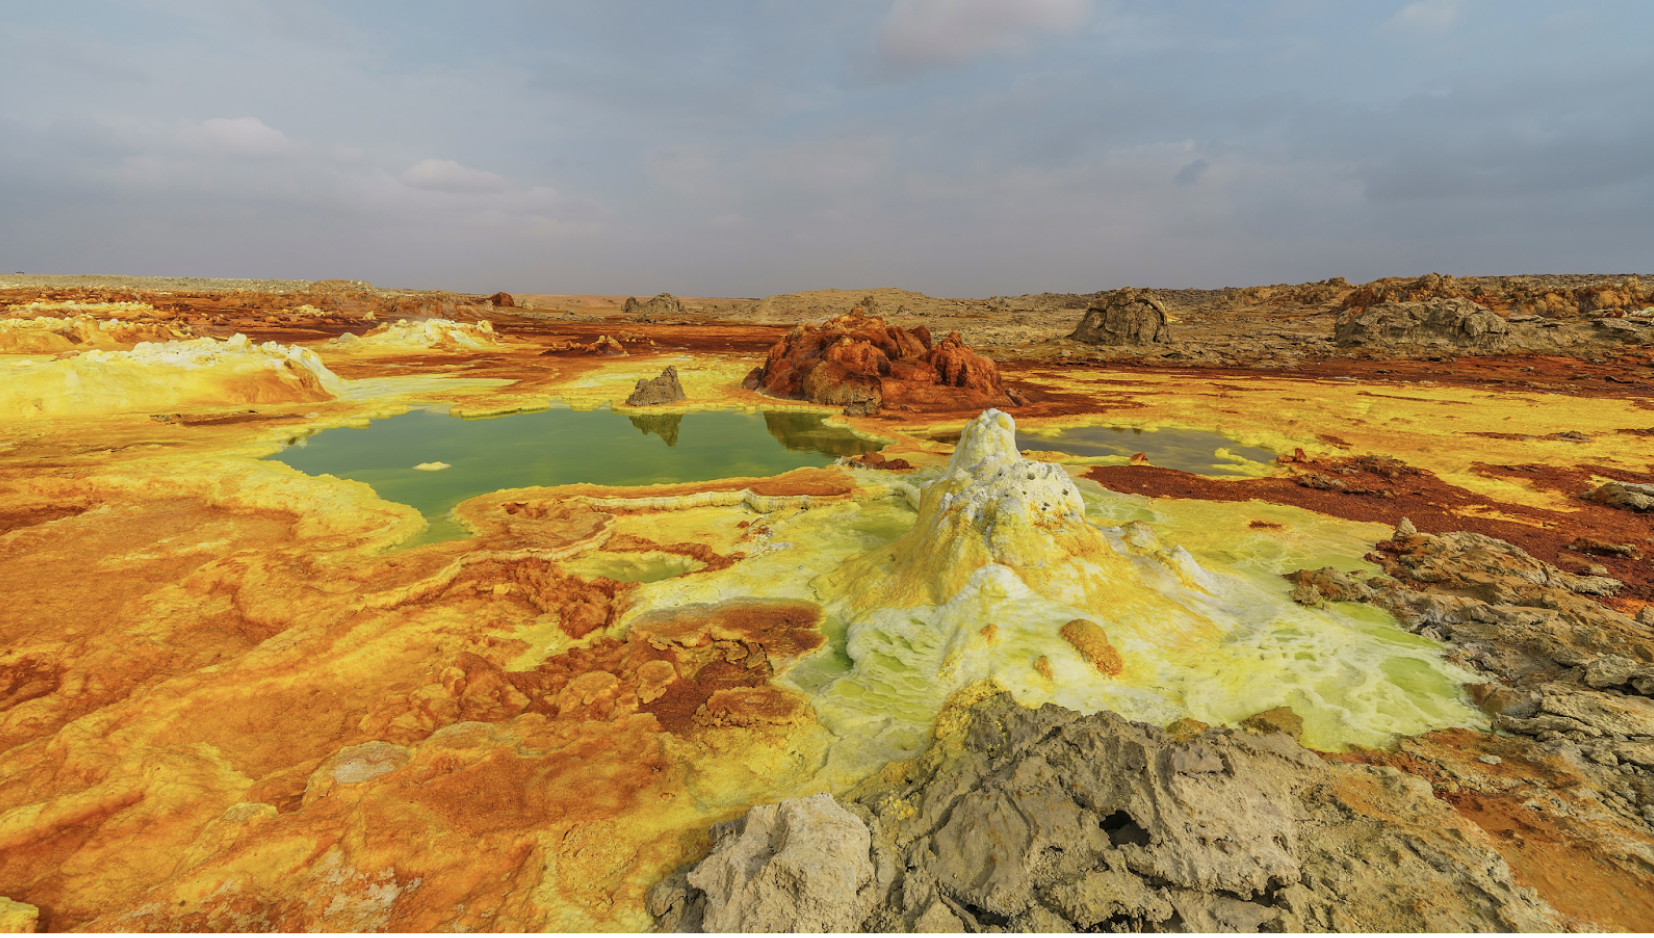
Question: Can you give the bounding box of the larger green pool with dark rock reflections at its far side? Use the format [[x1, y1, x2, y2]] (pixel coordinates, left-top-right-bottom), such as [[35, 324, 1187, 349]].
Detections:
[[271, 409, 883, 544]]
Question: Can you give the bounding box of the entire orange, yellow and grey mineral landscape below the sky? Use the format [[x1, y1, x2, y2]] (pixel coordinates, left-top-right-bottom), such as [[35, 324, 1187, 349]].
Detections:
[[0, 275, 1654, 931]]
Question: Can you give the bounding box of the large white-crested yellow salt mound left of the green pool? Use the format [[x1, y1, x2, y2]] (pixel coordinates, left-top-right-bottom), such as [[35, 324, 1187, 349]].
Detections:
[[0, 334, 342, 419]]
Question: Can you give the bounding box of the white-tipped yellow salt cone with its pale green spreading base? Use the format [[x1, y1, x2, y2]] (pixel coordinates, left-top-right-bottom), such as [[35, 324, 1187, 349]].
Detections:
[[815, 410, 1479, 768]]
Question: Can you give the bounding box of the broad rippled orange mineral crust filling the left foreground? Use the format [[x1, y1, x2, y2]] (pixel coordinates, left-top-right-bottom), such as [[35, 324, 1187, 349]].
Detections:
[[0, 459, 840, 931]]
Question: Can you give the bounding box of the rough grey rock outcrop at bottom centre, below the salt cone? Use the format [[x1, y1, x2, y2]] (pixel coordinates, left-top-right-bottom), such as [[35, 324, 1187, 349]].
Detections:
[[648, 693, 1561, 933]]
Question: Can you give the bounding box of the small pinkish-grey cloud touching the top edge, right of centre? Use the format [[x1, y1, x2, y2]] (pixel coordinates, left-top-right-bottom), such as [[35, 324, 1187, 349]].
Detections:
[[878, 0, 1092, 68]]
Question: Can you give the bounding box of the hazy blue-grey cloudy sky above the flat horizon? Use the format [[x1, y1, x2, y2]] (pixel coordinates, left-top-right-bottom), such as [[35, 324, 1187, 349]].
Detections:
[[0, 0, 1654, 296]]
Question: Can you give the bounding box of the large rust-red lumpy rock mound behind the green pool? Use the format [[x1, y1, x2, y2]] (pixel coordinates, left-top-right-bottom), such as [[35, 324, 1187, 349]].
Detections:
[[743, 306, 1011, 414]]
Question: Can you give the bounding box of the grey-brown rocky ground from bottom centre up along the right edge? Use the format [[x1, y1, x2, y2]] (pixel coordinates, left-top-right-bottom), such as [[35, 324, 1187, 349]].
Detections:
[[650, 524, 1654, 931]]
